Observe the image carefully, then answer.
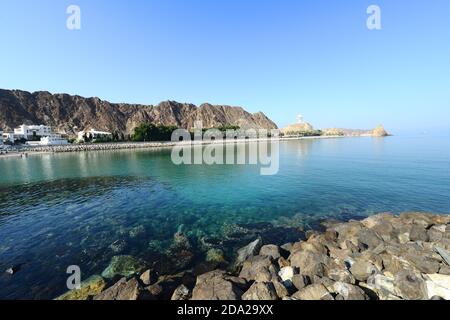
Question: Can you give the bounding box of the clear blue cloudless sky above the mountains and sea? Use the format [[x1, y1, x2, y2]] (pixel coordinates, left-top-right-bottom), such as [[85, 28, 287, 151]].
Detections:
[[0, 0, 450, 133]]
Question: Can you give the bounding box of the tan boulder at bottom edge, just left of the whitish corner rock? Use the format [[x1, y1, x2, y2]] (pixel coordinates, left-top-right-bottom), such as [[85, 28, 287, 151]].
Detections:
[[394, 270, 428, 300]]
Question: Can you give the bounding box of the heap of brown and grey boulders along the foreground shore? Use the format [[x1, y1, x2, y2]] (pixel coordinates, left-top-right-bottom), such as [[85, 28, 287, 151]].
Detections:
[[58, 212, 450, 300]]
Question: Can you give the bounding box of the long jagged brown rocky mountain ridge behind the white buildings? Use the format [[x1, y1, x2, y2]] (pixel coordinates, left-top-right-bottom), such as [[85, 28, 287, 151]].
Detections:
[[0, 89, 277, 134]]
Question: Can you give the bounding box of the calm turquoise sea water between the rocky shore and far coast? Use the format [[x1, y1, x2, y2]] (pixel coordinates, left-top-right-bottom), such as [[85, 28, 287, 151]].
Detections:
[[0, 136, 450, 299]]
